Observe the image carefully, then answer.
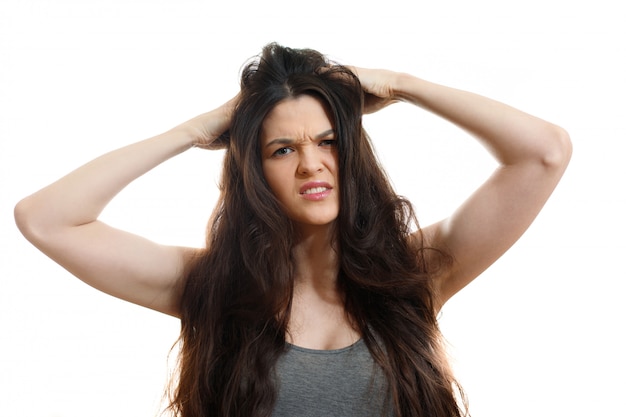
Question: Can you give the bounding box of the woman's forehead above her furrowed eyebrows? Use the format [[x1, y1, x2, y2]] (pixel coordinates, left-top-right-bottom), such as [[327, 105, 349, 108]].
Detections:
[[261, 95, 333, 142]]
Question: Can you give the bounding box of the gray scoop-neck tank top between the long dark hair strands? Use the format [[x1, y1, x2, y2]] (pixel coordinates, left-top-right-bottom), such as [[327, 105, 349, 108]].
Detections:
[[272, 340, 392, 417]]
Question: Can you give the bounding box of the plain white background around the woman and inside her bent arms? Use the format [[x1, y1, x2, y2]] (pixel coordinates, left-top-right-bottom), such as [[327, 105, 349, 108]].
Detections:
[[0, 0, 626, 417]]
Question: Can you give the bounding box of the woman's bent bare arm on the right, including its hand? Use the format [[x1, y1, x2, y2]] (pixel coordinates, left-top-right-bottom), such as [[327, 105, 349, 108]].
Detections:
[[356, 68, 572, 305]]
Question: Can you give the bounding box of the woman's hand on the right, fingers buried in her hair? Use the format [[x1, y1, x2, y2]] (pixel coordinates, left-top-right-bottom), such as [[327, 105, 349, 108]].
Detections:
[[350, 67, 400, 114]]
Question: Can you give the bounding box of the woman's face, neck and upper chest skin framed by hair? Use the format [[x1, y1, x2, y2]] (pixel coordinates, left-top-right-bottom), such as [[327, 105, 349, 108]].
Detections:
[[261, 96, 359, 349]]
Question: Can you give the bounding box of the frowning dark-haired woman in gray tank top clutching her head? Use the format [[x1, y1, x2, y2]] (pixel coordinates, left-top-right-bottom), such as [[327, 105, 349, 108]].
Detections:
[[15, 44, 571, 417]]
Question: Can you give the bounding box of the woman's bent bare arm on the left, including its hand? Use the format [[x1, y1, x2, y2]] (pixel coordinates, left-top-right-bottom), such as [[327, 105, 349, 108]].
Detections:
[[15, 99, 235, 316]]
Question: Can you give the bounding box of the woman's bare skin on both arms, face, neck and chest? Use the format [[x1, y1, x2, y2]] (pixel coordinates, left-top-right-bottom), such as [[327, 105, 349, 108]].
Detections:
[[15, 67, 571, 349]]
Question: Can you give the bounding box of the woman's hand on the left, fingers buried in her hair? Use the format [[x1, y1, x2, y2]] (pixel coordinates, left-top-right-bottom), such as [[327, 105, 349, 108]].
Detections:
[[175, 95, 239, 150]]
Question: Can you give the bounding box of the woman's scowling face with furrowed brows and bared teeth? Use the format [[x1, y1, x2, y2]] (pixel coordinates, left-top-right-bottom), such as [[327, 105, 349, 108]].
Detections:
[[261, 95, 339, 231]]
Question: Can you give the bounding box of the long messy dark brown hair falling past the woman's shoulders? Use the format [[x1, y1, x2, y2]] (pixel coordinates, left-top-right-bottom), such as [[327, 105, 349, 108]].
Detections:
[[169, 43, 466, 417]]
